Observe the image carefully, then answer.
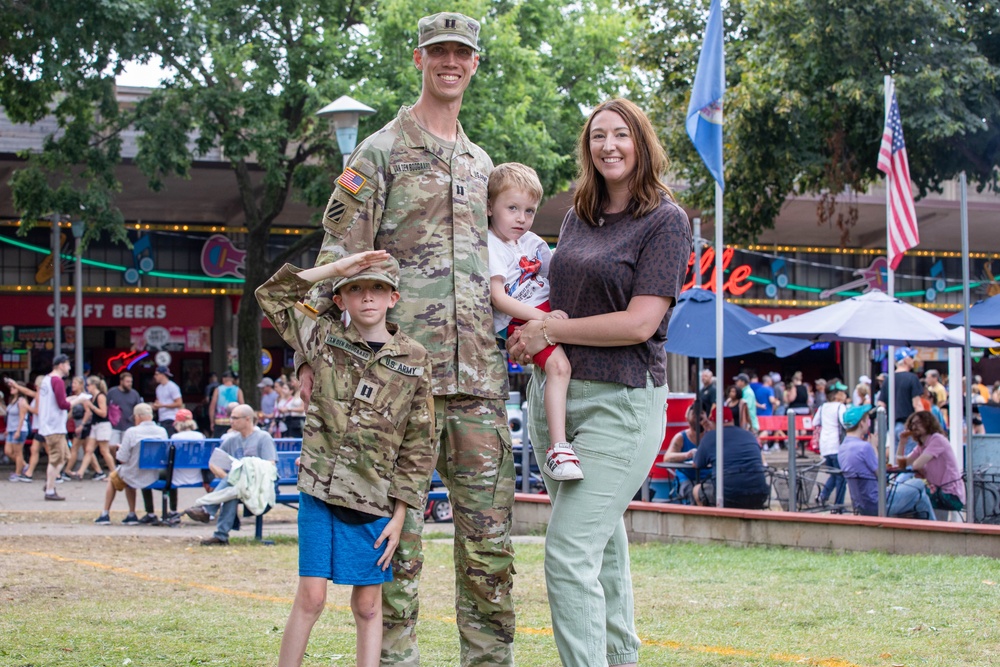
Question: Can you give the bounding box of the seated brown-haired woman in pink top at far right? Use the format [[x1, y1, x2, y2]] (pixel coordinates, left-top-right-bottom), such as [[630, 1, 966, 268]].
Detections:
[[896, 410, 965, 512]]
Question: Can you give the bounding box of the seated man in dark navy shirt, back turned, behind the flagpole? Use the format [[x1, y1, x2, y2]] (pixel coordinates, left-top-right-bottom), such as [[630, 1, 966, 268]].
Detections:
[[692, 407, 771, 509]]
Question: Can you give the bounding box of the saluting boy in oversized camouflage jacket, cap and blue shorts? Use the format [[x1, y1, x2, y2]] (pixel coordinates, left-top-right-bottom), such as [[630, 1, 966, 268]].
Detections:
[[256, 251, 437, 667]]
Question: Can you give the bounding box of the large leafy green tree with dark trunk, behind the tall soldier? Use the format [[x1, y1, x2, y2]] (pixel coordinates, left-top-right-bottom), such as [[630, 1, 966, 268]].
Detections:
[[0, 0, 628, 402]]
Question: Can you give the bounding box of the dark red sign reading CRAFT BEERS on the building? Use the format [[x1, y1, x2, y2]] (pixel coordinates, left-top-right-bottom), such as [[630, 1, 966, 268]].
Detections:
[[0, 295, 215, 327]]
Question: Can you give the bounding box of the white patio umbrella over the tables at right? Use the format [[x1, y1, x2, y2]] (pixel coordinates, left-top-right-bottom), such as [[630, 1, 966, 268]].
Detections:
[[751, 291, 996, 348]]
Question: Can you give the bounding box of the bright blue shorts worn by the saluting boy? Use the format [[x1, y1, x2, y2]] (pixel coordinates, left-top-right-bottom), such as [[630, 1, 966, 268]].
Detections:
[[299, 492, 392, 586]]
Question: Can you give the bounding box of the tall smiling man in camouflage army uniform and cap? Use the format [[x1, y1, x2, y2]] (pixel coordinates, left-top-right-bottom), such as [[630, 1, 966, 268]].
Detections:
[[300, 12, 514, 665]]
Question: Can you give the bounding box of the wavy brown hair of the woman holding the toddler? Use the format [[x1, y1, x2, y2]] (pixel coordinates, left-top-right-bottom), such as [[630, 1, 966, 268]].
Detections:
[[573, 98, 675, 225]]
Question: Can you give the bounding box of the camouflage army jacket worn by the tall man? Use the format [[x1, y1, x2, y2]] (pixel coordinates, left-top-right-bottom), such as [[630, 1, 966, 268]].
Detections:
[[312, 107, 507, 398]]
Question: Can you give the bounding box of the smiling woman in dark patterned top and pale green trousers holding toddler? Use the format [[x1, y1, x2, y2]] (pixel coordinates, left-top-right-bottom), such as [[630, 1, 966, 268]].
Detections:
[[508, 99, 691, 666]]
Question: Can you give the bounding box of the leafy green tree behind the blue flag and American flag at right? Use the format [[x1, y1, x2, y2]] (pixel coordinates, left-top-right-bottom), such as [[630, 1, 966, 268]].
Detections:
[[635, 0, 1000, 242]]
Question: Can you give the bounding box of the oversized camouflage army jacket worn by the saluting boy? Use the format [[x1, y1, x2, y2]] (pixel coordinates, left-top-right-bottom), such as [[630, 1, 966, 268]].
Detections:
[[256, 264, 437, 516]]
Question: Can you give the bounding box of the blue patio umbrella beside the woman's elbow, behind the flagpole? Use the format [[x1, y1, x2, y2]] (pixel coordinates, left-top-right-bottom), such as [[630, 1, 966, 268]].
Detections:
[[663, 287, 812, 359]]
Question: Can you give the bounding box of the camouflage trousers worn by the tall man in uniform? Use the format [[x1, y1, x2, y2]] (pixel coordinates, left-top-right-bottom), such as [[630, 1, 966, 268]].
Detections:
[[382, 395, 514, 667]]
